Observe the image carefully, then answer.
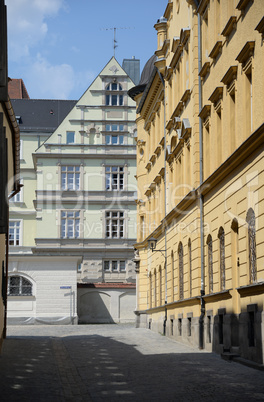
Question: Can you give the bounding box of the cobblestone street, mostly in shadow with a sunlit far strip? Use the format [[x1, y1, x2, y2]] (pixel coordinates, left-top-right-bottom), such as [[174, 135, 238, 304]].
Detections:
[[0, 325, 264, 402]]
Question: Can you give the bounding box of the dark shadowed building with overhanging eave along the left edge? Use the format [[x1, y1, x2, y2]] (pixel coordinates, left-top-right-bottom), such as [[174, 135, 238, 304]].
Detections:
[[0, 1, 20, 350]]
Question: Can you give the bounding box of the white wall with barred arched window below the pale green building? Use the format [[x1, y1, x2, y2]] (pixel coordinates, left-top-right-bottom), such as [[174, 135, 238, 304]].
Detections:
[[7, 256, 79, 324]]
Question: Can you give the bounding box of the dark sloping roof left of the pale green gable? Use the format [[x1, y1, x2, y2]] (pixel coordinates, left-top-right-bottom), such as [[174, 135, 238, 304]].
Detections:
[[11, 99, 77, 132]]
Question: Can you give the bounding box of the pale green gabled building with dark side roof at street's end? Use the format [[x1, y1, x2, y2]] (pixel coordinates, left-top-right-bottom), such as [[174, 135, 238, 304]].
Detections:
[[9, 58, 138, 323]]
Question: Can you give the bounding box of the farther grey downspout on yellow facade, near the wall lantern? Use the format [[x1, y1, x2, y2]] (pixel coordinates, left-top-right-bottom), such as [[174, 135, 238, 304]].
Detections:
[[158, 70, 168, 335]]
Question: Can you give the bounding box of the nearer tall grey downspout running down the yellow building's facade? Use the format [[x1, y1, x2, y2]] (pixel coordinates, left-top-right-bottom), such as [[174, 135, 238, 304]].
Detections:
[[198, 6, 205, 349]]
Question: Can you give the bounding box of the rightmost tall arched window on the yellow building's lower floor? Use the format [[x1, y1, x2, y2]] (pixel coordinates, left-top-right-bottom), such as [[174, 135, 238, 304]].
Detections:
[[246, 208, 257, 283]]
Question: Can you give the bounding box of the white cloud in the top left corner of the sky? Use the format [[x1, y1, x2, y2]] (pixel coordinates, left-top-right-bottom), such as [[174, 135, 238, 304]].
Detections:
[[6, 0, 64, 61]]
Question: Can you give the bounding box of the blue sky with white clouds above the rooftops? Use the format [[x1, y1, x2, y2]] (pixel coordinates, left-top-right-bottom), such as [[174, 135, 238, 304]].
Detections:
[[5, 0, 168, 100]]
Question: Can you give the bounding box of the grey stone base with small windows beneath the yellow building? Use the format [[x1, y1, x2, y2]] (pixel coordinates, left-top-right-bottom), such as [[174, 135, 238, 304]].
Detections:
[[142, 304, 264, 364]]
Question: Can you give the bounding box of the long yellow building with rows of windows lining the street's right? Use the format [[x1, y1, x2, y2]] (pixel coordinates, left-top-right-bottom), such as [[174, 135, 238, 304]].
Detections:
[[129, 0, 264, 364]]
